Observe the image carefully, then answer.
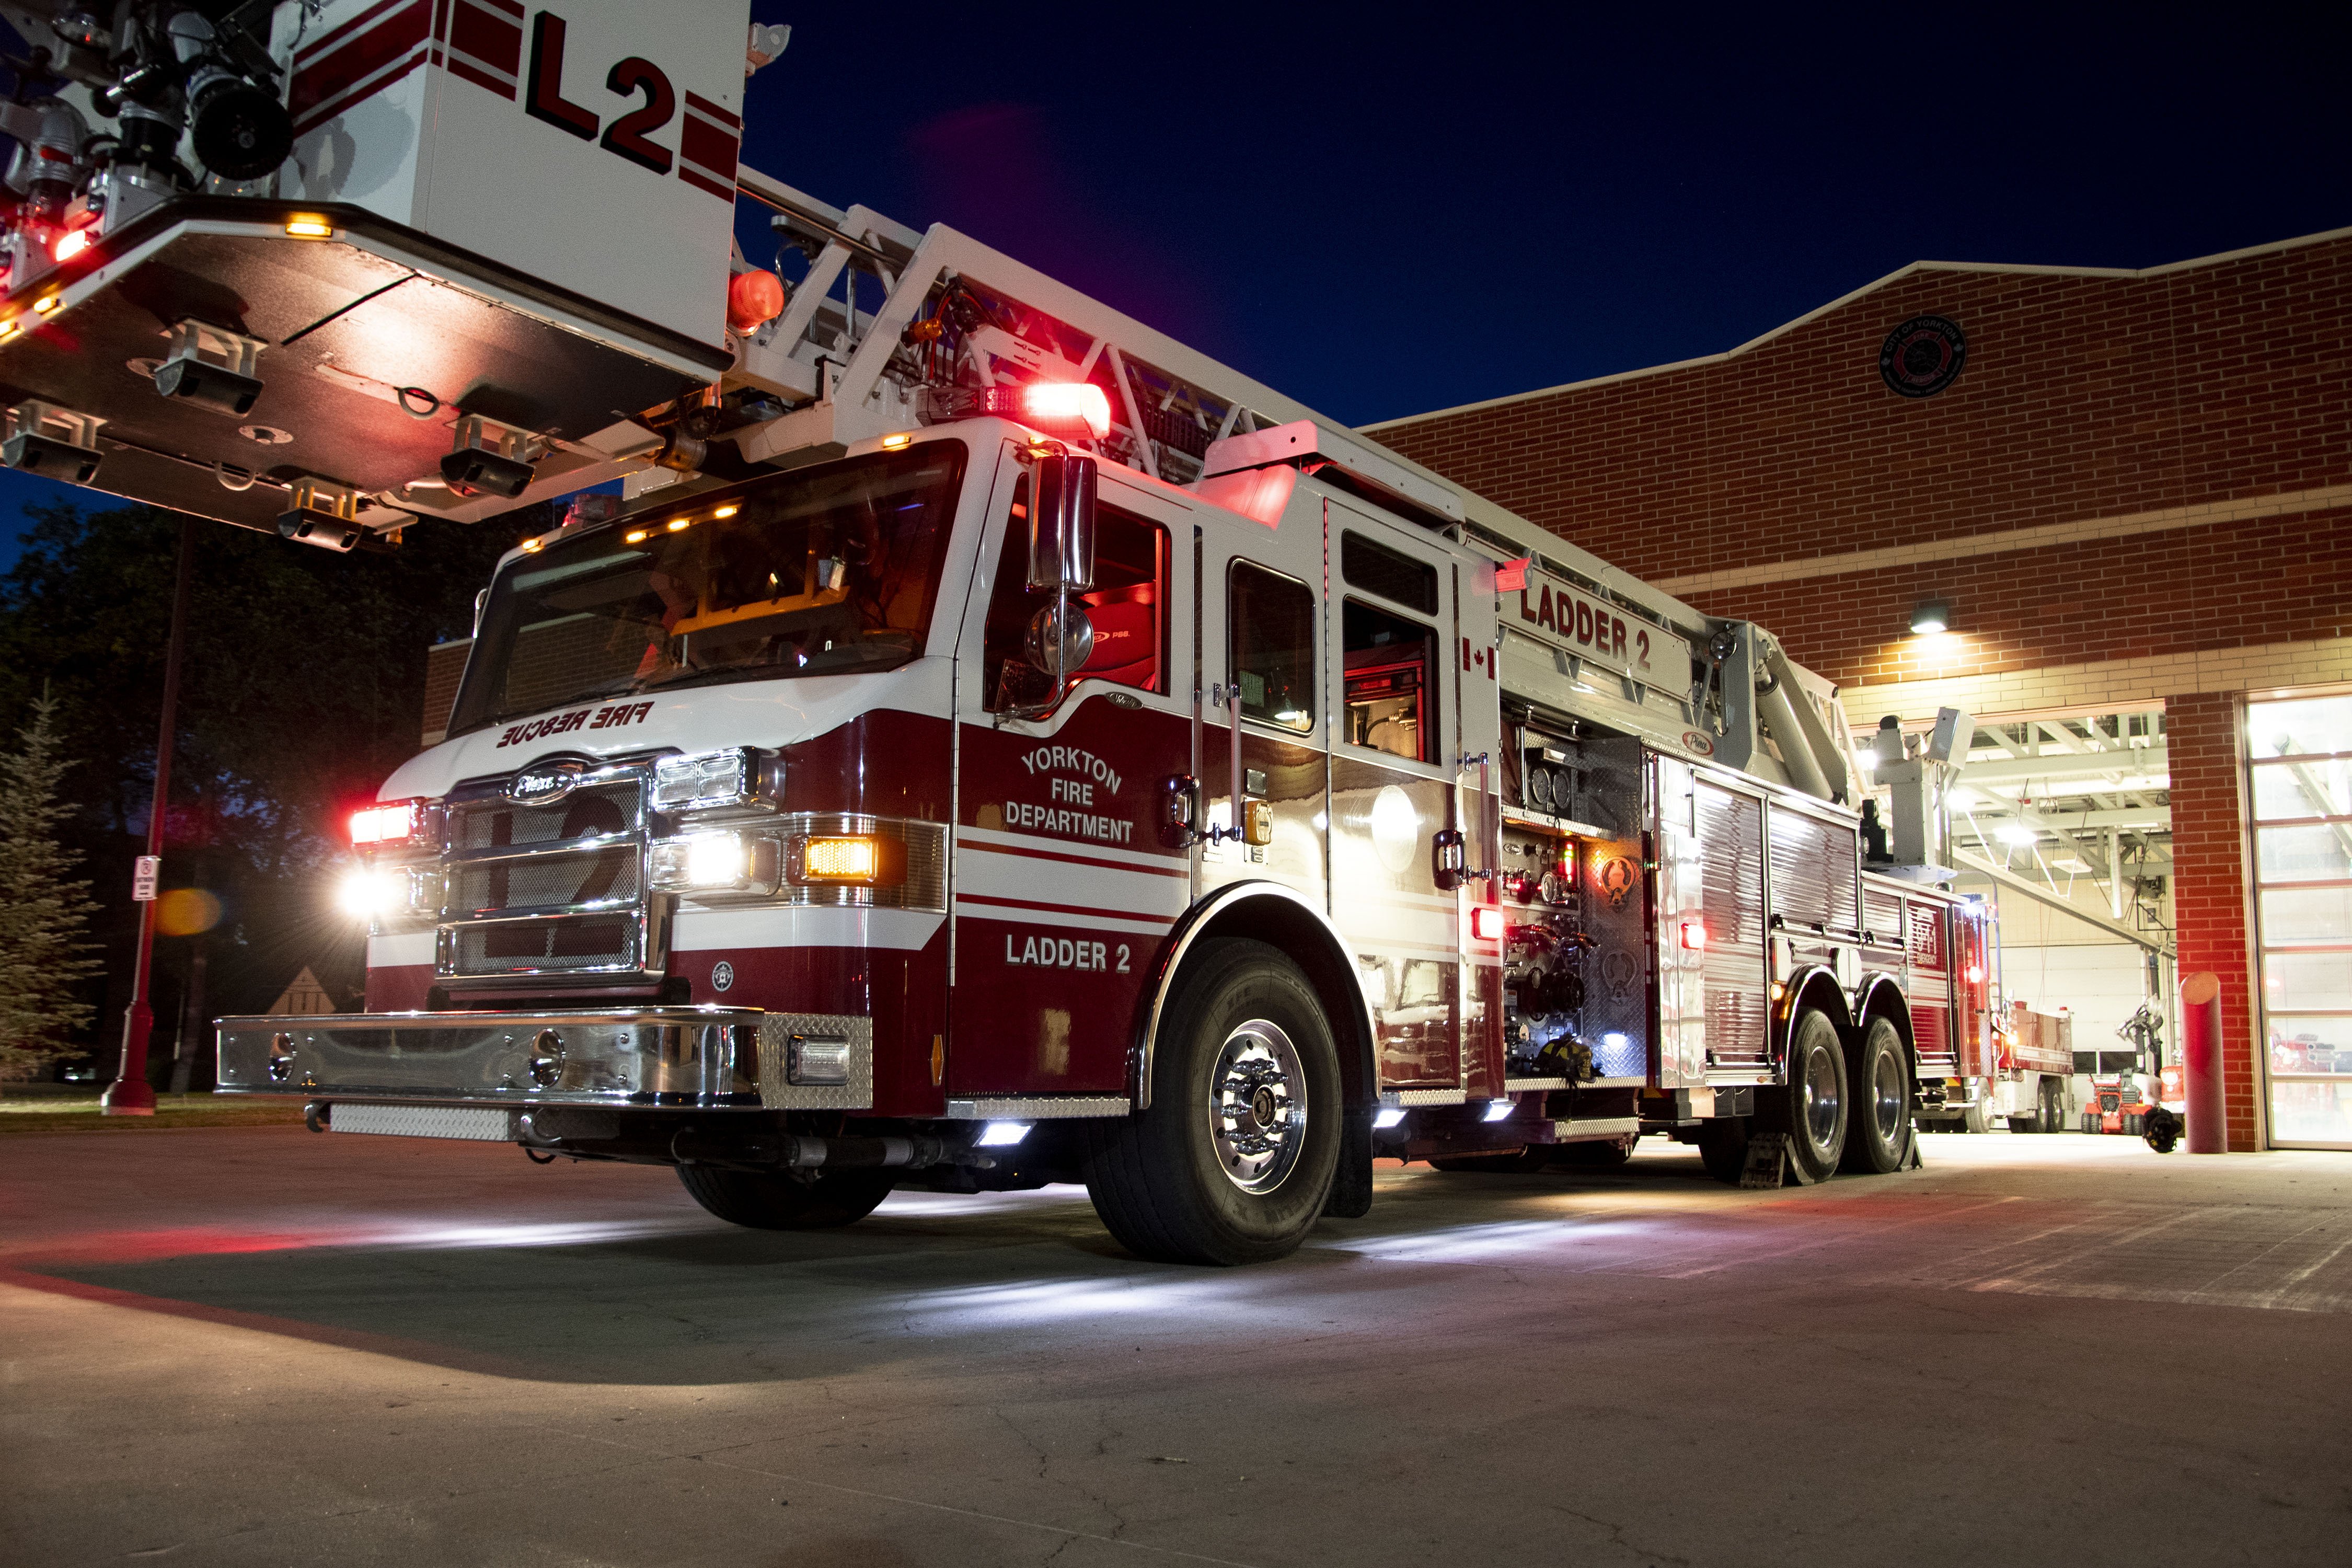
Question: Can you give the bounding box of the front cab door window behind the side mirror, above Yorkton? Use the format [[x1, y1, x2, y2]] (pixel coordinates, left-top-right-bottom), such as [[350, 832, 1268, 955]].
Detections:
[[981, 477, 1169, 712]]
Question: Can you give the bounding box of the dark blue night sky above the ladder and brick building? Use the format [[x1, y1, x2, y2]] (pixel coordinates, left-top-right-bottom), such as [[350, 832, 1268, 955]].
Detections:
[[0, 0, 2352, 559]]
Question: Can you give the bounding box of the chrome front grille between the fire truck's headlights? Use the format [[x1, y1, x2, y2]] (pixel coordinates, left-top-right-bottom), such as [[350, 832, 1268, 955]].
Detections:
[[435, 764, 663, 981]]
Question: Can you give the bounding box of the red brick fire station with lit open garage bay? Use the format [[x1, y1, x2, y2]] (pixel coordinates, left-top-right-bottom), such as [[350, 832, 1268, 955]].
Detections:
[[1369, 230, 2352, 1149]]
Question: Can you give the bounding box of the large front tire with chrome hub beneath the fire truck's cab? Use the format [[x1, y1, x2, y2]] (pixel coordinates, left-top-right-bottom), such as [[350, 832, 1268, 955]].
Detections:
[[1085, 938, 1343, 1265]]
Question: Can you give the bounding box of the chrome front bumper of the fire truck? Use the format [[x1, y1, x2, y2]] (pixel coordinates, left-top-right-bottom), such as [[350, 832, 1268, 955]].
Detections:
[[219, 1006, 875, 1110]]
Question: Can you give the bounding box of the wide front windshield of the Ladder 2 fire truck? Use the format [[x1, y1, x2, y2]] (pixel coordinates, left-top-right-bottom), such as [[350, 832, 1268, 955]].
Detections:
[[449, 442, 964, 733]]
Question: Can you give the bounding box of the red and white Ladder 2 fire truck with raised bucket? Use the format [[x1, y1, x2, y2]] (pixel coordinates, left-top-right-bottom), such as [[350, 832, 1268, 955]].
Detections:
[[0, 0, 1990, 1262]]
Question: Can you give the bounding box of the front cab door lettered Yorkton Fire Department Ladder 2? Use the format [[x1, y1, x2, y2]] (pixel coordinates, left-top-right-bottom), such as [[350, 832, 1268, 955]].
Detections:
[[946, 444, 1193, 1100]]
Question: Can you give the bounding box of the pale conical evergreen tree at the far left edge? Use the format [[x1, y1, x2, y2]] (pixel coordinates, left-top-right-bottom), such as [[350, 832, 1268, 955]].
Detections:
[[0, 691, 99, 1079]]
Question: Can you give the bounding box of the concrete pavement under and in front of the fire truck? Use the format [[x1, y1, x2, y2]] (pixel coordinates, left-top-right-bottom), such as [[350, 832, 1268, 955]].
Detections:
[[0, 1128, 2352, 1568]]
